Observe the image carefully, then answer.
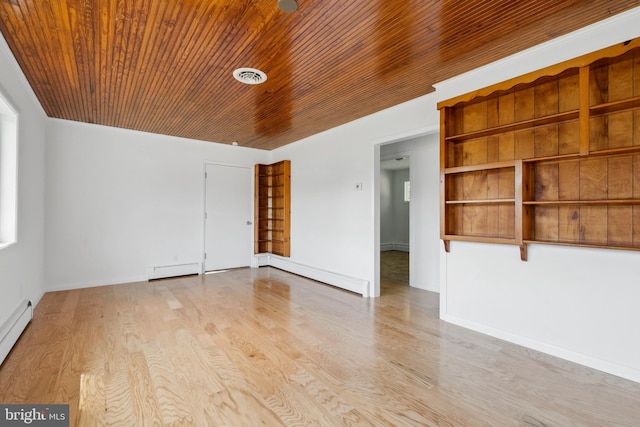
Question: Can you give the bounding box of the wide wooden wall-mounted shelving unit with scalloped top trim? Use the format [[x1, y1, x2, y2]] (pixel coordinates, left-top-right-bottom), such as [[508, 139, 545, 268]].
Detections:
[[438, 39, 640, 260]]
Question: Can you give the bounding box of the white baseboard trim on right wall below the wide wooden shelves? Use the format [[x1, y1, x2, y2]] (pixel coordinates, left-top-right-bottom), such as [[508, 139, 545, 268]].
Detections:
[[440, 313, 640, 383]]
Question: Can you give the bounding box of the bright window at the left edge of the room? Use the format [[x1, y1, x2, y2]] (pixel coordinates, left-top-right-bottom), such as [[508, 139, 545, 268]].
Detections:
[[0, 94, 18, 248]]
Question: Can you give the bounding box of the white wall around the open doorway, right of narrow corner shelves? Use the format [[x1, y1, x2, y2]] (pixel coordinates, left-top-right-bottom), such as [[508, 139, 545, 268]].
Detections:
[[273, 95, 439, 296]]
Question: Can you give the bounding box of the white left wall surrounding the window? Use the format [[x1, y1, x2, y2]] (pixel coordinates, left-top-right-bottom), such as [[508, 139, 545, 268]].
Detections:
[[0, 35, 46, 325]]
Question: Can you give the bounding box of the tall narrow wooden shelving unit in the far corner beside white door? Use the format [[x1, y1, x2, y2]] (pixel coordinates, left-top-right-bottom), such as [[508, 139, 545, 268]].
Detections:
[[254, 160, 291, 257]]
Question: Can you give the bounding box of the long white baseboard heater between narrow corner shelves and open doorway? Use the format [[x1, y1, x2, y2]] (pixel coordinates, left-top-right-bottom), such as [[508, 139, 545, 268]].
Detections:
[[259, 255, 369, 297]]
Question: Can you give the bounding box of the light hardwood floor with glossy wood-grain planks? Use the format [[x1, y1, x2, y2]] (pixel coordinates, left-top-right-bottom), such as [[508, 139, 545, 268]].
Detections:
[[0, 268, 640, 426]]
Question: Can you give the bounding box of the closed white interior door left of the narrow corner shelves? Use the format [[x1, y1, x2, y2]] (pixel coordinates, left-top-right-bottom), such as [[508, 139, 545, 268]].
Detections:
[[204, 164, 253, 271]]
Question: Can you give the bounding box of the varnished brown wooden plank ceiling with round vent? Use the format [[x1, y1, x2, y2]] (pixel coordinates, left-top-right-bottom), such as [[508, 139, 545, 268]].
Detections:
[[0, 0, 640, 149]]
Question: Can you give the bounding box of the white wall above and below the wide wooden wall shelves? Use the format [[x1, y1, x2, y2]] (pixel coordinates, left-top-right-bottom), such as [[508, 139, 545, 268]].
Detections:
[[437, 8, 640, 381]]
